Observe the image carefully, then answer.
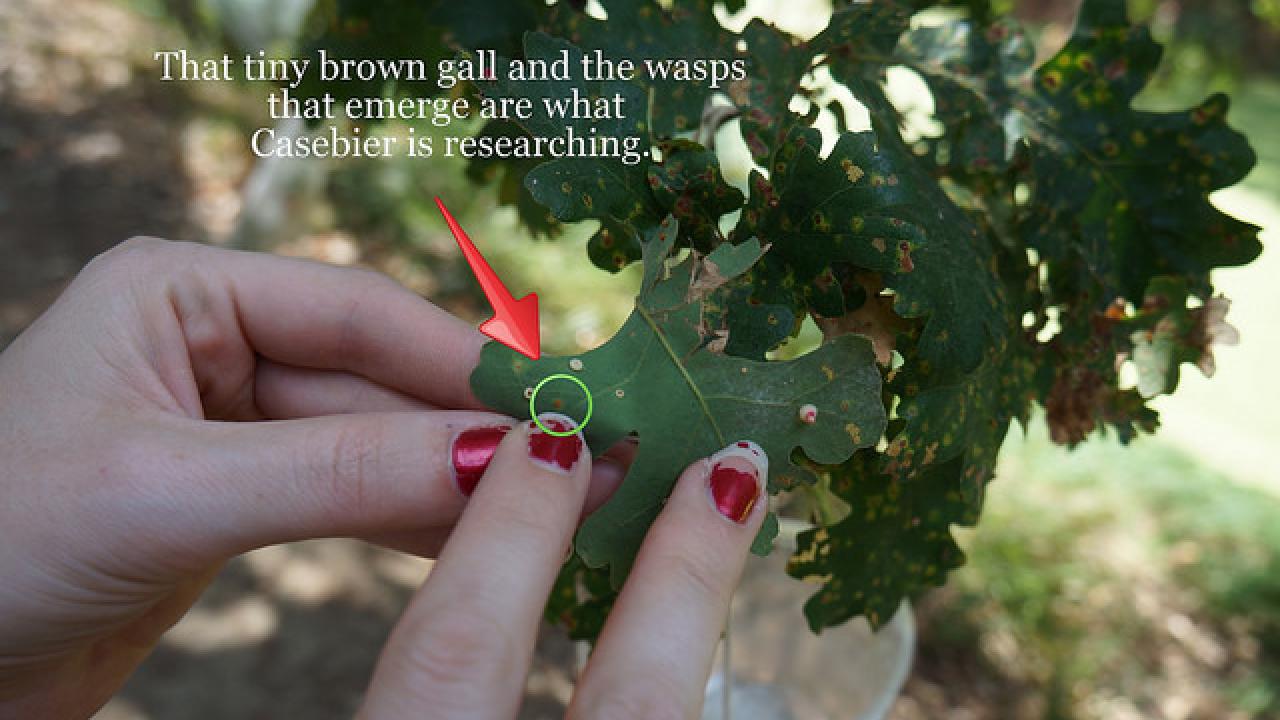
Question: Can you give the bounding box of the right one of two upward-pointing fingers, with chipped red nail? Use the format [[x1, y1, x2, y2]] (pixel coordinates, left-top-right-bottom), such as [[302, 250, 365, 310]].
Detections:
[[570, 442, 768, 717]]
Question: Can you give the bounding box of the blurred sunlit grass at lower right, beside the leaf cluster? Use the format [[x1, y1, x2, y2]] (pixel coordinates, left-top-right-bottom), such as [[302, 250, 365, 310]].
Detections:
[[933, 423, 1280, 717]]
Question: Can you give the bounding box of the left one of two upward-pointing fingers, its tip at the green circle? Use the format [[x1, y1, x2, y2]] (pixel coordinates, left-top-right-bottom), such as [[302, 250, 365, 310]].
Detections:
[[362, 414, 591, 717]]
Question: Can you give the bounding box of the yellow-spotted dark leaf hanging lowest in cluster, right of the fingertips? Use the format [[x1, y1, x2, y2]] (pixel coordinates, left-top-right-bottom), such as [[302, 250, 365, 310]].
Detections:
[[787, 281, 1036, 632]]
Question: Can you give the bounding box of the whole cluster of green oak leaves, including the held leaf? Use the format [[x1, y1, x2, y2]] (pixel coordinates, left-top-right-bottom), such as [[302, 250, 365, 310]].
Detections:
[[302, 0, 1261, 637]]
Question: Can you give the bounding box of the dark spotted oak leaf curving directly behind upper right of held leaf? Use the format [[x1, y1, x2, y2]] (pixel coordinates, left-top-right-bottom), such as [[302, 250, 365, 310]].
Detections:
[[733, 122, 1005, 372]]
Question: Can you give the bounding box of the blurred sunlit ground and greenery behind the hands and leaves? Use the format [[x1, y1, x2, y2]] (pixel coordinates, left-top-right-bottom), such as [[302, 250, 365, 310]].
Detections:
[[0, 0, 1280, 720]]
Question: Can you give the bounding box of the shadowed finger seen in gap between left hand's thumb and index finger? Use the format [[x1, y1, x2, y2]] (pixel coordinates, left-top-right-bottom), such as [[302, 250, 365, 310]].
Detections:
[[253, 360, 435, 420]]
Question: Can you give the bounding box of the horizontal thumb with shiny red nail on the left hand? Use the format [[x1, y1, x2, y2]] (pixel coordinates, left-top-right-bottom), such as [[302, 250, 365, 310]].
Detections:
[[179, 411, 515, 556]]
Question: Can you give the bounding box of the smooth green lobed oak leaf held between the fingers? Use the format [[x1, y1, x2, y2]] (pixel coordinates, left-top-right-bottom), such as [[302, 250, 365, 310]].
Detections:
[[472, 218, 884, 587]]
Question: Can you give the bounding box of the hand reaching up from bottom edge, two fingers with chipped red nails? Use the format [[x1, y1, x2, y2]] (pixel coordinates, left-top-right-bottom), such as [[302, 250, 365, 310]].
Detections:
[[361, 415, 768, 720]]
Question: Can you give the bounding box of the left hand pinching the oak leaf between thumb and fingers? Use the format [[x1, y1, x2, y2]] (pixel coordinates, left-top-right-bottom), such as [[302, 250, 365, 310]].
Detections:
[[0, 240, 622, 717]]
